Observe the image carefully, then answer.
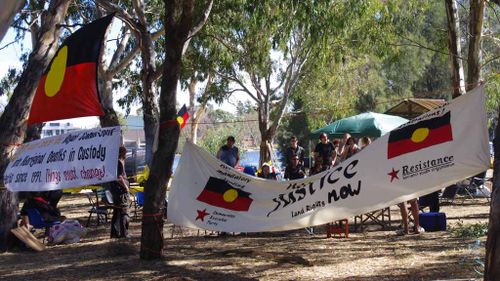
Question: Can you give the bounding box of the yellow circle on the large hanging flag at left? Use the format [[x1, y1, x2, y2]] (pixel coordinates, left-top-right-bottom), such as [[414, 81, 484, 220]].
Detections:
[[44, 46, 68, 97]]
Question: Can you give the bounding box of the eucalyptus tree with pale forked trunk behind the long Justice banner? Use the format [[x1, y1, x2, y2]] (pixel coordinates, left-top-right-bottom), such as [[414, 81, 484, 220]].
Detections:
[[197, 0, 428, 162]]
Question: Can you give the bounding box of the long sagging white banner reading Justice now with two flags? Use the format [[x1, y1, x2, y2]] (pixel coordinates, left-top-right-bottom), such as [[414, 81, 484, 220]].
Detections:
[[168, 87, 489, 232]]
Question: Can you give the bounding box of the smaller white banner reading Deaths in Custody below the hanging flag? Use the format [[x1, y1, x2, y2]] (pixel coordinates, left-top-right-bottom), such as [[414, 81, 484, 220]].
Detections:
[[4, 127, 121, 191]]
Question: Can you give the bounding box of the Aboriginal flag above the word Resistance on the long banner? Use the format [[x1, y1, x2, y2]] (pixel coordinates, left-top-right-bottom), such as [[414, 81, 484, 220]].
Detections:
[[387, 112, 453, 159]]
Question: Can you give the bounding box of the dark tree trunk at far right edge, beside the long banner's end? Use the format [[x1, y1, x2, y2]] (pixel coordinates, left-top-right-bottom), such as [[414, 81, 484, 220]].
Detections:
[[484, 107, 500, 281]]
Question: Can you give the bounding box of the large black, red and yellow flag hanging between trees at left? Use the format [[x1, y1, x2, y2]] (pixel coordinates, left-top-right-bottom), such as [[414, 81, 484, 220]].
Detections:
[[28, 14, 114, 124]]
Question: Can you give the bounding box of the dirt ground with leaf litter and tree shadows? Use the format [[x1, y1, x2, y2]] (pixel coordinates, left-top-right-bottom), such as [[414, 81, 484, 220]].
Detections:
[[0, 188, 489, 281]]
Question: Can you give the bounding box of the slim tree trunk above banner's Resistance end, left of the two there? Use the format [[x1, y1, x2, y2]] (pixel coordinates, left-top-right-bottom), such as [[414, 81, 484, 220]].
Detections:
[[445, 0, 465, 98]]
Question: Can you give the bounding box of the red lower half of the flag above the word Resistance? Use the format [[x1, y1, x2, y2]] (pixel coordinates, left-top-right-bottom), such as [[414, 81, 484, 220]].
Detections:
[[387, 124, 453, 159]]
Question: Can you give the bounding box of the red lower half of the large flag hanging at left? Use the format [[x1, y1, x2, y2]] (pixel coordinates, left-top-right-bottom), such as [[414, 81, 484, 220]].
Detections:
[[28, 62, 104, 124]]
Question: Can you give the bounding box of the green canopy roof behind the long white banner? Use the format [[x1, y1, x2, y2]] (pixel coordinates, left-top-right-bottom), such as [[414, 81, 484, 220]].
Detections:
[[309, 112, 408, 139]]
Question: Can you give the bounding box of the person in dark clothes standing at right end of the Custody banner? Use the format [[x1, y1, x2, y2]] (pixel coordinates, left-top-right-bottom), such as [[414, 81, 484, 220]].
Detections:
[[110, 146, 130, 238]]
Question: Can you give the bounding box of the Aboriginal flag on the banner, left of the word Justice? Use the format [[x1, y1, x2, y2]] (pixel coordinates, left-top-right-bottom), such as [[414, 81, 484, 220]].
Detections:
[[196, 177, 253, 212]]
